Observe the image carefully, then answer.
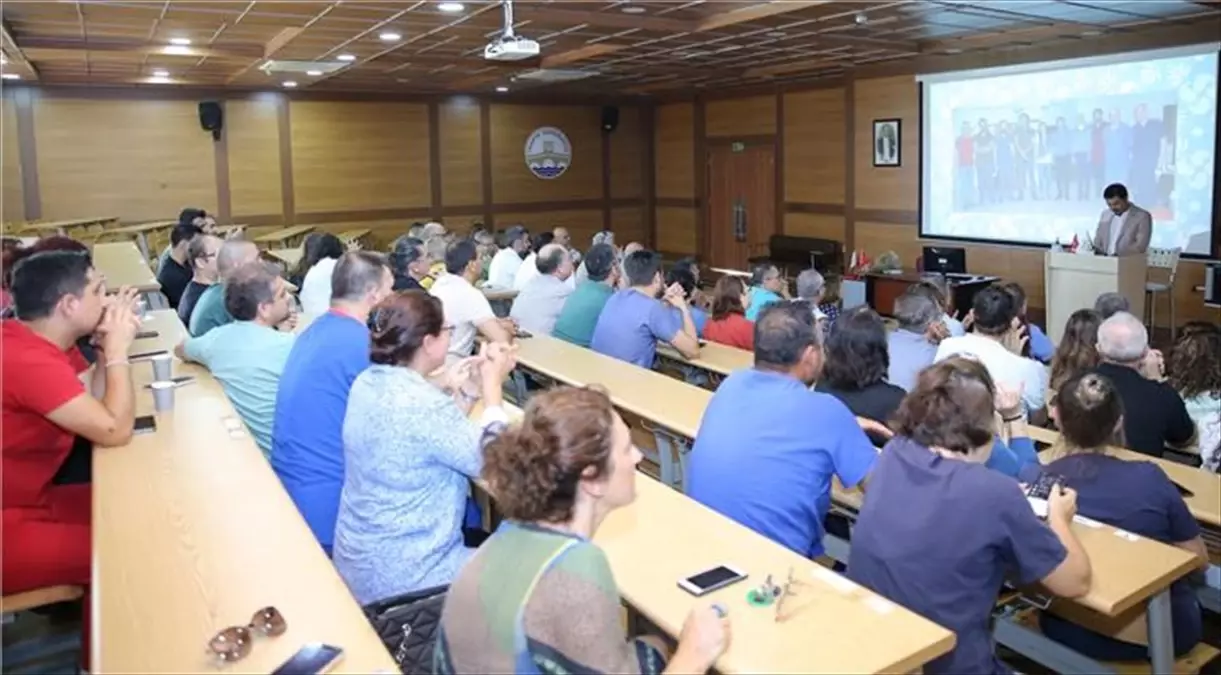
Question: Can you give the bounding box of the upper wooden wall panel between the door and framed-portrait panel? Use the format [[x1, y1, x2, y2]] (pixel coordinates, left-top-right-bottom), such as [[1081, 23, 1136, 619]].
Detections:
[[784, 89, 847, 204]]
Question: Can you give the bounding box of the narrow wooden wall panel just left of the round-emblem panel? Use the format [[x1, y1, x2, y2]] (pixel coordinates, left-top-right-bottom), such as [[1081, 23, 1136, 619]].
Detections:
[[438, 98, 484, 206]]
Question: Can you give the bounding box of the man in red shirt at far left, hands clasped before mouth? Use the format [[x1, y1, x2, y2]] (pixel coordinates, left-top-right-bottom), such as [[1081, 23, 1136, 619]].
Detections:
[[0, 250, 140, 658]]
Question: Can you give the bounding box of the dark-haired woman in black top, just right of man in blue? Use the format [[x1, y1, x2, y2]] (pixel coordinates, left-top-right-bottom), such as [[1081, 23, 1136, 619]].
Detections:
[[816, 305, 907, 424]]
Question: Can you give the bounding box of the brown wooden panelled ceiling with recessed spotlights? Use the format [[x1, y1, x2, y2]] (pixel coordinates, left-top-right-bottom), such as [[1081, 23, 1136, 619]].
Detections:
[[0, 0, 1221, 95]]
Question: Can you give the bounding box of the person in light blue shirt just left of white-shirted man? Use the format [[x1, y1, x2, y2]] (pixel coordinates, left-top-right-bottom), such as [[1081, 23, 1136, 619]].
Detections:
[[886, 286, 945, 392]]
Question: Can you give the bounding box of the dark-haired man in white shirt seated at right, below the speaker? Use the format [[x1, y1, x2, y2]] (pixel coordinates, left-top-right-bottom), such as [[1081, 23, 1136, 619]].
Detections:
[[934, 286, 1048, 415]]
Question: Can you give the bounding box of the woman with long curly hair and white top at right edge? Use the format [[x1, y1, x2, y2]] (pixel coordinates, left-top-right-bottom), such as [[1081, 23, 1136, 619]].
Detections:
[[1166, 321, 1221, 471]]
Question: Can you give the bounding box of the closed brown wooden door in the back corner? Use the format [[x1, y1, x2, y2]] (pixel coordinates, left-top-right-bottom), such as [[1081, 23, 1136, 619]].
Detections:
[[707, 145, 779, 270]]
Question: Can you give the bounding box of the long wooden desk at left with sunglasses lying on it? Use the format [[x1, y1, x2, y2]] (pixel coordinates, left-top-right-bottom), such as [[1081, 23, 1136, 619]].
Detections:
[[101, 314, 397, 673]]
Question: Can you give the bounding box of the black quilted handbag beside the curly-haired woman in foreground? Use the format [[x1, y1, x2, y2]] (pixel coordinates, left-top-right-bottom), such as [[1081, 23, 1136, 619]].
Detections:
[[361, 586, 449, 675]]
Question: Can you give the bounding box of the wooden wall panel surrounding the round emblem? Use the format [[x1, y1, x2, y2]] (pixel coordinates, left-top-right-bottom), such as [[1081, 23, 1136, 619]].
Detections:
[[491, 104, 602, 204]]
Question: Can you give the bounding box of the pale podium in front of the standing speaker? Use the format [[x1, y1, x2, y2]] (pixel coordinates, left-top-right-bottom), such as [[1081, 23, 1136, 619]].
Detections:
[[1043, 250, 1147, 344]]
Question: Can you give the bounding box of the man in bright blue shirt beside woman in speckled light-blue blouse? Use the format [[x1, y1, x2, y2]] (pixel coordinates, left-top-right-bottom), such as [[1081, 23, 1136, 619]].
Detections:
[[271, 250, 395, 554]]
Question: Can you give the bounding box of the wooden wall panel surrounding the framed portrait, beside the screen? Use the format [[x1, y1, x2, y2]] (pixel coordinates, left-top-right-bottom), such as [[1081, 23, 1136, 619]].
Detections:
[[853, 76, 919, 210]]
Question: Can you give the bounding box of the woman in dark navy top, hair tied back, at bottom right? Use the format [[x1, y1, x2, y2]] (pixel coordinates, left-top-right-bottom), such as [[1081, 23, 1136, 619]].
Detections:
[[1040, 374, 1209, 662]]
